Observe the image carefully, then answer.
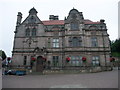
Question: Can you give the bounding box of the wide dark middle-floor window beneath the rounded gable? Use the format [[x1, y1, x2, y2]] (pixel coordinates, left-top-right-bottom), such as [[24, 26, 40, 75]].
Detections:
[[69, 37, 82, 47]]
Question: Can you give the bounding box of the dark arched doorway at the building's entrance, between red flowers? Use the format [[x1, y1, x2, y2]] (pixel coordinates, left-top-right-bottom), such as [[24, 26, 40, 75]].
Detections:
[[36, 56, 44, 72]]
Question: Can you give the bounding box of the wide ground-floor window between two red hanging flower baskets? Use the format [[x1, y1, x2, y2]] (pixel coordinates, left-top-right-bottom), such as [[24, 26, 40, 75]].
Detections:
[[70, 56, 83, 66]]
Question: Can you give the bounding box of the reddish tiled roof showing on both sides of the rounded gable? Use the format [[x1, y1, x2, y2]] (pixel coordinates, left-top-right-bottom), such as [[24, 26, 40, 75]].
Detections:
[[42, 19, 100, 25]]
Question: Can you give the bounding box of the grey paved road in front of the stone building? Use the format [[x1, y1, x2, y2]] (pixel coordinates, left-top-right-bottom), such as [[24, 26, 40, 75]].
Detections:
[[2, 70, 118, 88]]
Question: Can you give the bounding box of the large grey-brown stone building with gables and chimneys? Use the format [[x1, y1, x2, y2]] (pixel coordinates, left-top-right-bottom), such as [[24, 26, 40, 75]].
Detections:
[[12, 8, 110, 70]]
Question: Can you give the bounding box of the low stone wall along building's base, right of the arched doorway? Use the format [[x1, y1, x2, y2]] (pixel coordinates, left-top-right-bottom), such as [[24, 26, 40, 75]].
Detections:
[[33, 67, 112, 75]]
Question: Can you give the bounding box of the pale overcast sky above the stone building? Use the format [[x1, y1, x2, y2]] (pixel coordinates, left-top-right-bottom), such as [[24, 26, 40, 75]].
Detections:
[[0, 0, 119, 56]]
